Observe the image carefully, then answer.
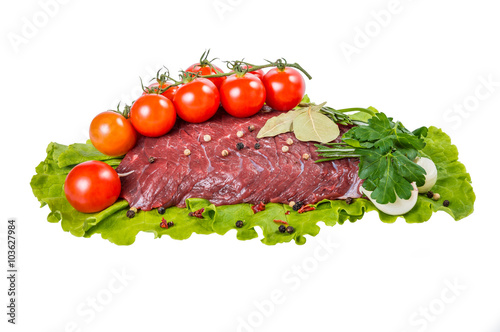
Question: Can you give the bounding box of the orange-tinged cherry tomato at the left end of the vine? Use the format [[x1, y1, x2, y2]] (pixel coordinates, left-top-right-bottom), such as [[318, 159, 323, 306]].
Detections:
[[89, 111, 137, 156]]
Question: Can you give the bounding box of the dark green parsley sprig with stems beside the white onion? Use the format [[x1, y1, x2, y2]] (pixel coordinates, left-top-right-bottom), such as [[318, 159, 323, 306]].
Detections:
[[316, 113, 427, 204]]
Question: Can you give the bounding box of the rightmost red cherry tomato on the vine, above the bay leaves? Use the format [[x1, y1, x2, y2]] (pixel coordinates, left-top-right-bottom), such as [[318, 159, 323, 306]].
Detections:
[[262, 67, 306, 111]]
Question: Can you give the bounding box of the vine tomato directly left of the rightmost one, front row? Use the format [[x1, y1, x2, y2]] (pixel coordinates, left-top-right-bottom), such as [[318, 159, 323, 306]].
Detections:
[[220, 73, 266, 118]]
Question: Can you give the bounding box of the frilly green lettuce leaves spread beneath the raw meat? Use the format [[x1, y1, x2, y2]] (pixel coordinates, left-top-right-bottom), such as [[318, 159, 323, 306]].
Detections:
[[31, 127, 476, 245]]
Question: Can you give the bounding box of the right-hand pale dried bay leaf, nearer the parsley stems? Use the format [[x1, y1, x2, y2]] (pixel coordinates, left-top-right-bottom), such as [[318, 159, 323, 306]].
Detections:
[[292, 107, 340, 143]]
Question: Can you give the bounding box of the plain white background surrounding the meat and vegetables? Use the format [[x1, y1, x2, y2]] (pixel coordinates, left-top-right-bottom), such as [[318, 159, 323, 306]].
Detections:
[[0, 0, 500, 332]]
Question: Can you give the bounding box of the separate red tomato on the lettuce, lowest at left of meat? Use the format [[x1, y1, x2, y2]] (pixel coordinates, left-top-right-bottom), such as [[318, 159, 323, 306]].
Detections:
[[64, 160, 121, 213]]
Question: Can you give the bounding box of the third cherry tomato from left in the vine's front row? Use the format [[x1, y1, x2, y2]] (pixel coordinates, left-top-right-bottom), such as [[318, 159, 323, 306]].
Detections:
[[174, 78, 220, 123]]
